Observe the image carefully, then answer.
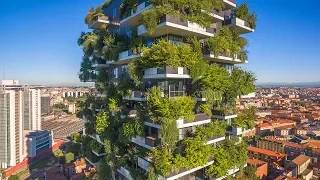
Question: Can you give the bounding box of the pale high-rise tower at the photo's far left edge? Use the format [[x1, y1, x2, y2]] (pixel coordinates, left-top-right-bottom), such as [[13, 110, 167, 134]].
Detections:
[[0, 80, 41, 168]]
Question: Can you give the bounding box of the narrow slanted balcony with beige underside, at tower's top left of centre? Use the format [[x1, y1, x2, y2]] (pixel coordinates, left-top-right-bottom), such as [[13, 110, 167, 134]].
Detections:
[[120, 2, 152, 26]]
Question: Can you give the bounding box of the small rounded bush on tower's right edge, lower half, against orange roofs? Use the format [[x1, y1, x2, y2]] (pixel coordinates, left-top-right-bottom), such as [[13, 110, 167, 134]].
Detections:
[[233, 106, 257, 129]]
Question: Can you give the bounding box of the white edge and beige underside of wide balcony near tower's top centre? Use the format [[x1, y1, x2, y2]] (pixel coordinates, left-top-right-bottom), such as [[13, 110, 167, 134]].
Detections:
[[138, 22, 214, 39]]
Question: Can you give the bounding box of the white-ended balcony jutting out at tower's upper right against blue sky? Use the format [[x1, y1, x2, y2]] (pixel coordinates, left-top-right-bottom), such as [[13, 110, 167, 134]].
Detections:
[[223, 17, 254, 34]]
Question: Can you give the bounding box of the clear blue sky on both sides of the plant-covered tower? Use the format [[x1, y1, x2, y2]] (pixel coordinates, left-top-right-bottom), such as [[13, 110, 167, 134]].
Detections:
[[0, 0, 320, 85]]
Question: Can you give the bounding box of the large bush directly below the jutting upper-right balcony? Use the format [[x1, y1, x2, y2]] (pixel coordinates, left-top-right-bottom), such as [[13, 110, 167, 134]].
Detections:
[[207, 27, 247, 62]]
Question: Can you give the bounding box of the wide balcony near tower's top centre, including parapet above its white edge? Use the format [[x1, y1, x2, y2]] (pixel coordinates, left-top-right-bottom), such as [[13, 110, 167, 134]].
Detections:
[[138, 15, 215, 39]]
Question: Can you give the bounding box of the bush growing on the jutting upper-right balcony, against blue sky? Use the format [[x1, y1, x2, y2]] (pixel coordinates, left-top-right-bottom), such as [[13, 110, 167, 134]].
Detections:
[[234, 3, 257, 29]]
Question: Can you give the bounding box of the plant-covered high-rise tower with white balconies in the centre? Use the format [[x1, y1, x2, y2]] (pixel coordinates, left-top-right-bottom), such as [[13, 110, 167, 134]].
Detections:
[[78, 0, 256, 180]]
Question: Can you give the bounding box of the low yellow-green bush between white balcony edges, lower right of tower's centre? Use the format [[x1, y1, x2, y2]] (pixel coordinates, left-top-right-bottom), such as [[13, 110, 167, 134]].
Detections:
[[196, 120, 227, 140]]
